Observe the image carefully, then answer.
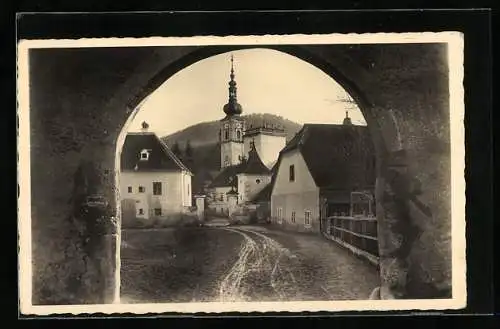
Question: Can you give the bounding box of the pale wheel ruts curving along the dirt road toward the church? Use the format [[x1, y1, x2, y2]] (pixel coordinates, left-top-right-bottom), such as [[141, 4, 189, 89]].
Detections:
[[219, 227, 297, 302]]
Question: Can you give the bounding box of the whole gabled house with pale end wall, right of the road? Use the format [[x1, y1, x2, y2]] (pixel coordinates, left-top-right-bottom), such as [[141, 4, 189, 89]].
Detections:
[[271, 120, 375, 231]]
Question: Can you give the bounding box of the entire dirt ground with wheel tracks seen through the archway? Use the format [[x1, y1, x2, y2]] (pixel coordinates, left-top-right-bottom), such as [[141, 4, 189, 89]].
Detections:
[[121, 226, 378, 302]]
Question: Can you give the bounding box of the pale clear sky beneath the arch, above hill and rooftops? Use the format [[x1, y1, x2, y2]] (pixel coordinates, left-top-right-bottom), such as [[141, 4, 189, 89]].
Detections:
[[129, 49, 366, 136]]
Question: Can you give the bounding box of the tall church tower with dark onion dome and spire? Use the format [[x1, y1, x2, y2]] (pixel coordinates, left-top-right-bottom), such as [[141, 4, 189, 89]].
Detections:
[[219, 55, 245, 169]]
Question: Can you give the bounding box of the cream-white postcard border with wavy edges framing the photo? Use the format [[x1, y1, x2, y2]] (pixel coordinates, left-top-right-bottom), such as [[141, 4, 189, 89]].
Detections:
[[17, 31, 467, 315]]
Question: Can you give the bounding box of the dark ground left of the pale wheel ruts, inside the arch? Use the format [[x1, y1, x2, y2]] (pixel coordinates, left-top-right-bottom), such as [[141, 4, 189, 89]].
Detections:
[[121, 228, 241, 303]]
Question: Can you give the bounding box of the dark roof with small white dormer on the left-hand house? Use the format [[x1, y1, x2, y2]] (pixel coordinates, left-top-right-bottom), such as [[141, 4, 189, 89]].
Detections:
[[120, 132, 191, 173]]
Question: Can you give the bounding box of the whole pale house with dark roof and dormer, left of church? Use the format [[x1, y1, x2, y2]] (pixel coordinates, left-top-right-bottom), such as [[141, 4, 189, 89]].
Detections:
[[120, 123, 192, 219]]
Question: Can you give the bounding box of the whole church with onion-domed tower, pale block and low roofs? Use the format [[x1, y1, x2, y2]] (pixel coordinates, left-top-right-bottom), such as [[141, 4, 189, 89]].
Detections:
[[207, 56, 286, 215]]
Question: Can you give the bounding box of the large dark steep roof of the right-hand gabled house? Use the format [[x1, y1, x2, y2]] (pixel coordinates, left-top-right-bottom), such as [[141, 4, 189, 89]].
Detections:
[[278, 124, 375, 189]]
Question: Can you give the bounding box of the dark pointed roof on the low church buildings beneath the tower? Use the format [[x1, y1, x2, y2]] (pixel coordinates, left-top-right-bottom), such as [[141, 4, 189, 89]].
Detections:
[[210, 144, 271, 187]]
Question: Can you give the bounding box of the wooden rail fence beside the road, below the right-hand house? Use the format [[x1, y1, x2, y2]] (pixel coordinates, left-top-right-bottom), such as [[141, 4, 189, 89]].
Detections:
[[322, 216, 378, 264]]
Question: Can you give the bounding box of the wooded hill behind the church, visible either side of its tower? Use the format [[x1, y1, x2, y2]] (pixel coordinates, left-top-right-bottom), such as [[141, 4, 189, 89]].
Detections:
[[162, 113, 302, 192]]
